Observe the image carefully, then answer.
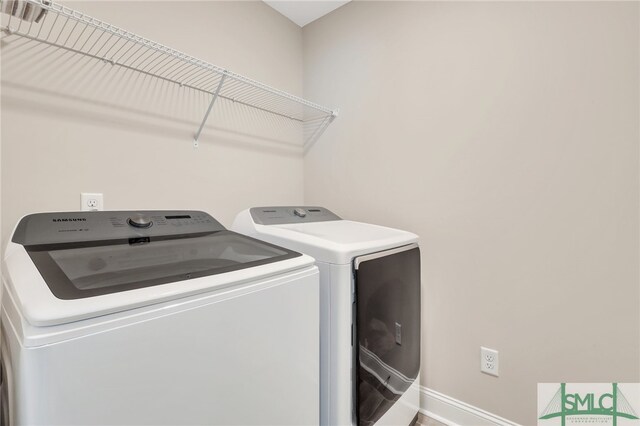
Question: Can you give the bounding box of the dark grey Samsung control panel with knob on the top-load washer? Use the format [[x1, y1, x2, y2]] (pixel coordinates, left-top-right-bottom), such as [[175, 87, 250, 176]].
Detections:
[[12, 210, 225, 246]]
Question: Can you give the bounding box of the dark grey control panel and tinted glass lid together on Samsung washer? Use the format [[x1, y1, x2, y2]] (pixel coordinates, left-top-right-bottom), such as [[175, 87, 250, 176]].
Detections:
[[13, 211, 300, 300]]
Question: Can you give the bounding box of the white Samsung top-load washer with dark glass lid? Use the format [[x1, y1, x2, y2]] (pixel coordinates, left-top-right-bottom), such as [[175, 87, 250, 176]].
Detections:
[[1, 211, 319, 425]]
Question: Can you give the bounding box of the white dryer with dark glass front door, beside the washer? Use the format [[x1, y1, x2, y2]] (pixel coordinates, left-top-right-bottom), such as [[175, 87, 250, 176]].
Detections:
[[233, 207, 420, 426]]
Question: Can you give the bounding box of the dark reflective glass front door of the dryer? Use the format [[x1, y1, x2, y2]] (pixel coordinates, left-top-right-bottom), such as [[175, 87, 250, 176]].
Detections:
[[354, 244, 420, 426]]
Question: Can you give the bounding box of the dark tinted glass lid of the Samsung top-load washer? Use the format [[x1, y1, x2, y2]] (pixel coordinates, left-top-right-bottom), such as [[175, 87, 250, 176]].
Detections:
[[26, 231, 300, 299]]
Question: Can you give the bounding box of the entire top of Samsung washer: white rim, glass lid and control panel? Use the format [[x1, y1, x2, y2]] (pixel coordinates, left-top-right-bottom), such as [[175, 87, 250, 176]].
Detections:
[[5, 211, 312, 325]]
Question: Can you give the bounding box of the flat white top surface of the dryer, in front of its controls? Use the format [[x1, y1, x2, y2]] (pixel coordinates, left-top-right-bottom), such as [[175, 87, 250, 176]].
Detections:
[[255, 220, 418, 264]]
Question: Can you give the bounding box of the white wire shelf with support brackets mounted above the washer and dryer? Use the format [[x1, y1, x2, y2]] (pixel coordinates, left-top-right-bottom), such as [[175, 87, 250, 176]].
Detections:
[[0, 0, 337, 147]]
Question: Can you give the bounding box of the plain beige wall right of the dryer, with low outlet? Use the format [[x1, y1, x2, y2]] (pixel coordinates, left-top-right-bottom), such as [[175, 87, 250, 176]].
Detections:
[[303, 1, 640, 424]]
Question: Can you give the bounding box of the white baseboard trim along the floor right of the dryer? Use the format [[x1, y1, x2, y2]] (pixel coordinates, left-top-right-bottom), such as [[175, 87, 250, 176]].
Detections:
[[420, 386, 519, 426]]
